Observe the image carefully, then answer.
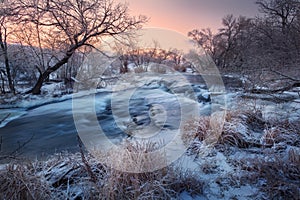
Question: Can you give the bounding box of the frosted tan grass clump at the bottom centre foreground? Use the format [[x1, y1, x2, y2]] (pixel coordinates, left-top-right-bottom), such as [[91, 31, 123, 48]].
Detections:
[[99, 167, 203, 199]]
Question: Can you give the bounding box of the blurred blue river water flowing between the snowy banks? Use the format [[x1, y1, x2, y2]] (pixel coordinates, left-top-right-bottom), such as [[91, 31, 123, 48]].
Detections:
[[0, 74, 224, 161]]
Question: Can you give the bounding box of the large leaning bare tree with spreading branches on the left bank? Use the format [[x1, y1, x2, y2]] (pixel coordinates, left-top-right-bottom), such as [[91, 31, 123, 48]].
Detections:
[[15, 0, 147, 94]]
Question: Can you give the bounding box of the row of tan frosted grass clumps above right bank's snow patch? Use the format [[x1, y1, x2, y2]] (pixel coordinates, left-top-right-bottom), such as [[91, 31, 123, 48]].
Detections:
[[182, 110, 300, 154]]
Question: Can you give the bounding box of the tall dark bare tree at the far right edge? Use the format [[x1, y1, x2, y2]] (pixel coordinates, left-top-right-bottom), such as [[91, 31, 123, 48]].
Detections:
[[252, 0, 300, 87]]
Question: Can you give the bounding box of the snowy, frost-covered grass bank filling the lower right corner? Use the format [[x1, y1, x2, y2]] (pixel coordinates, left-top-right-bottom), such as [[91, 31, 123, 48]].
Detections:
[[182, 107, 300, 199]]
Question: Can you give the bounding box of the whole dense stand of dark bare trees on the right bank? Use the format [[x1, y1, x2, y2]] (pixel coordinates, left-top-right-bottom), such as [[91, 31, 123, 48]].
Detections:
[[188, 0, 300, 88]]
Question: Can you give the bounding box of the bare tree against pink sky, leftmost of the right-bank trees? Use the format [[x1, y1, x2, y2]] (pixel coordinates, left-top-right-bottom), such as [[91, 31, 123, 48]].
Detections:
[[188, 15, 252, 69]]
